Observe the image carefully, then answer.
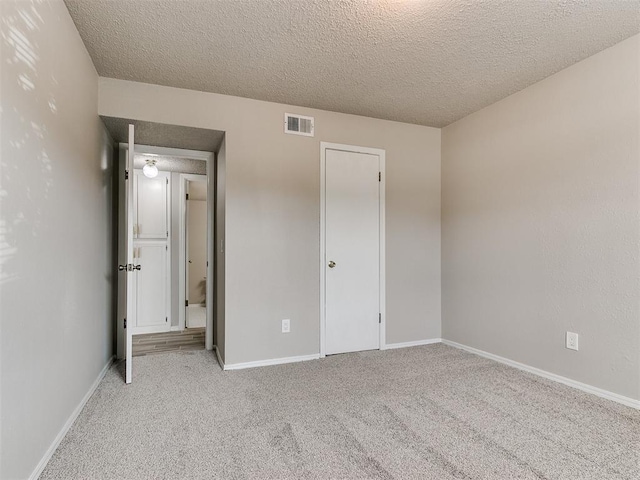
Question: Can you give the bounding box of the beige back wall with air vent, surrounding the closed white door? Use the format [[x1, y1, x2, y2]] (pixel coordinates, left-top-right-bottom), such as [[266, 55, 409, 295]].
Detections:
[[99, 78, 440, 364]]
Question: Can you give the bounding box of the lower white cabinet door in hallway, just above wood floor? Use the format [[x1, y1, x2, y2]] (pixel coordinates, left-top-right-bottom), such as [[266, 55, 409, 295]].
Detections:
[[135, 241, 170, 333]]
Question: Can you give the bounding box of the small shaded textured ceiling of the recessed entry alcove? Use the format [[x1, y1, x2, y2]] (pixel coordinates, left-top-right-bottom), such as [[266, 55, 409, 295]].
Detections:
[[100, 116, 224, 152]]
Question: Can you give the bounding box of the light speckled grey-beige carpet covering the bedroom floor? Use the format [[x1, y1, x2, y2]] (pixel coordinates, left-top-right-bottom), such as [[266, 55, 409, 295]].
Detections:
[[41, 344, 640, 480]]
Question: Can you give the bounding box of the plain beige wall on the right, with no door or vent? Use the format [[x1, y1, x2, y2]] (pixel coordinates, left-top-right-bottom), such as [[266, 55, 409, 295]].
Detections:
[[442, 36, 640, 399]]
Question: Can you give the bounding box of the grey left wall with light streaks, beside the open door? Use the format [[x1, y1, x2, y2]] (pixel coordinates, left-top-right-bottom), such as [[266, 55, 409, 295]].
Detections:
[[0, 0, 114, 479]]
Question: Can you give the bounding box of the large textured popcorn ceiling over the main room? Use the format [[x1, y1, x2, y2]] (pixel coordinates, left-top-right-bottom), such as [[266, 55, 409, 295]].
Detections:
[[71, 0, 640, 126]]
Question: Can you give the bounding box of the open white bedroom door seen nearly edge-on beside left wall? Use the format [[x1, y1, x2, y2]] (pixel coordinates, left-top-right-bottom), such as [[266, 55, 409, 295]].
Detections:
[[118, 125, 140, 383]]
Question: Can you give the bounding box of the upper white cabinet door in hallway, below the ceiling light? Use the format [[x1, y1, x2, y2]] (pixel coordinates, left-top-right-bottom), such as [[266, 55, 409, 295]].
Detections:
[[133, 170, 169, 239]]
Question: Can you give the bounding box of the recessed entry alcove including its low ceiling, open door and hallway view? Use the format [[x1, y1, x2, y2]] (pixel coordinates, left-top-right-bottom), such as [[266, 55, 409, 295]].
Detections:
[[102, 117, 224, 383]]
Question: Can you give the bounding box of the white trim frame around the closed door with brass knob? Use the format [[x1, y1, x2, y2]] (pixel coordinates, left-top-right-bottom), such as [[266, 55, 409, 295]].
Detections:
[[320, 142, 387, 358]]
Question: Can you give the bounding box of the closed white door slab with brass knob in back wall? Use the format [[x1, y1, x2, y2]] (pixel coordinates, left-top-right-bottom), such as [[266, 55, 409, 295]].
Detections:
[[324, 149, 380, 354]]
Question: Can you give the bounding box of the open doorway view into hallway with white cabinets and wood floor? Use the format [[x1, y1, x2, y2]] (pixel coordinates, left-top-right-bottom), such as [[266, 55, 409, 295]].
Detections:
[[132, 149, 213, 357]]
